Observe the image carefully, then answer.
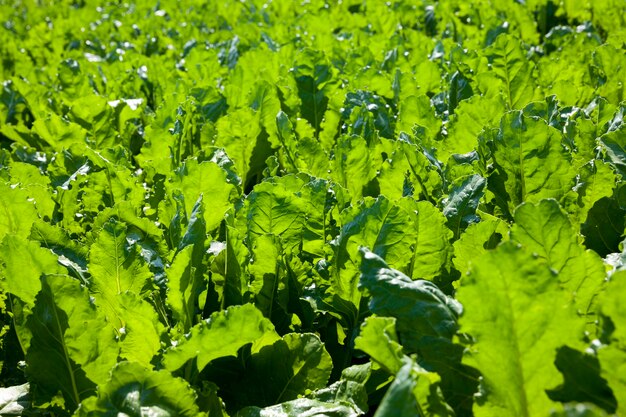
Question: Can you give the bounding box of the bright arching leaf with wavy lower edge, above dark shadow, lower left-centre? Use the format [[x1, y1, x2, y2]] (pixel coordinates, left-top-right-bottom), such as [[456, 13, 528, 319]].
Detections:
[[163, 304, 278, 371]]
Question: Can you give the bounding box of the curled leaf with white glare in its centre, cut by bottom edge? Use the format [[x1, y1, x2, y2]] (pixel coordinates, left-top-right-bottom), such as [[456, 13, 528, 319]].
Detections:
[[74, 362, 200, 417]]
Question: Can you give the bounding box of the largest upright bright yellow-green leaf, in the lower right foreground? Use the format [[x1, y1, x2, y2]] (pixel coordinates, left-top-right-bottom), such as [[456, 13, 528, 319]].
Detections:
[[457, 243, 583, 417]]
